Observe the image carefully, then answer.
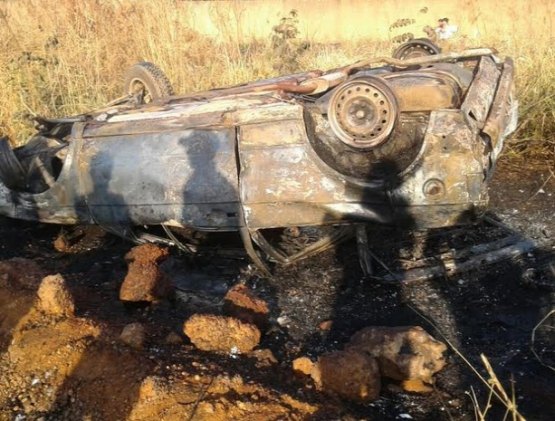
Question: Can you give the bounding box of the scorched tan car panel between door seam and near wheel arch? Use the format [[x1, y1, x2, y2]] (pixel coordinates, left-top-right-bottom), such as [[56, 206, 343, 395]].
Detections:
[[239, 120, 391, 228]]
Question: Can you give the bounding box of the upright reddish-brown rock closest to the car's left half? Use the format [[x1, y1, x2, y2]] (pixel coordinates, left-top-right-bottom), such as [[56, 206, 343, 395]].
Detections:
[[119, 244, 174, 302]]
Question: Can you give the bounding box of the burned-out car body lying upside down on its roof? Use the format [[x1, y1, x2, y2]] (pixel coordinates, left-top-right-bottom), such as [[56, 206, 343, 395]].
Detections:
[[0, 49, 516, 272]]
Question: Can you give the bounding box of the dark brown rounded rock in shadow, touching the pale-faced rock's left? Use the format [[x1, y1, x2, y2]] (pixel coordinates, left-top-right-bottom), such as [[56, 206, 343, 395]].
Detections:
[[317, 350, 381, 403]]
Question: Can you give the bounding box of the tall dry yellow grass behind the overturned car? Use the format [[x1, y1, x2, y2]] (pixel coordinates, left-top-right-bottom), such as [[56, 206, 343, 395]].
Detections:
[[0, 0, 555, 159]]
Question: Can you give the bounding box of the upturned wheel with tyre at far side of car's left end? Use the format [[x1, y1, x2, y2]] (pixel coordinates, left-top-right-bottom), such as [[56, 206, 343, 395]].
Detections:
[[123, 61, 173, 104]]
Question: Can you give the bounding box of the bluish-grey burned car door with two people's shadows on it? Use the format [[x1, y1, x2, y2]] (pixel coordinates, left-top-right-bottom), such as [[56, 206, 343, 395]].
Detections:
[[79, 128, 239, 230]]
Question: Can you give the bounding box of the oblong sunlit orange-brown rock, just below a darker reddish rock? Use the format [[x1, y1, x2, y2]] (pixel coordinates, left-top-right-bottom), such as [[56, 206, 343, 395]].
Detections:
[[183, 314, 260, 354]]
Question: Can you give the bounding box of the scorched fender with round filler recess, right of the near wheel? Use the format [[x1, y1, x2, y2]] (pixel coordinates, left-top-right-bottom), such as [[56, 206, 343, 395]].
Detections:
[[391, 110, 488, 227]]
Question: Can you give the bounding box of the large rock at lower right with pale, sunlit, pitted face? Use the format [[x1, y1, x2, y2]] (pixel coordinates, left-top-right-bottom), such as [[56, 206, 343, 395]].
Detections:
[[347, 326, 447, 383]]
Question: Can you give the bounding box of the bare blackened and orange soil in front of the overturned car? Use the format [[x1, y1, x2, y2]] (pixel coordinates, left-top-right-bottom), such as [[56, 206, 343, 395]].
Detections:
[[0, 161, 555, 420]]
